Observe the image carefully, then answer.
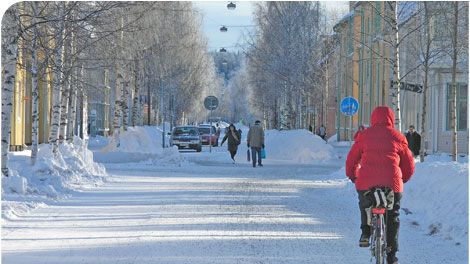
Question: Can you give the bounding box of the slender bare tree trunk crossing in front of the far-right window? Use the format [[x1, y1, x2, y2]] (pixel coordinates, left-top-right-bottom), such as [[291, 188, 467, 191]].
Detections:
[[450, 1, 459, 161]]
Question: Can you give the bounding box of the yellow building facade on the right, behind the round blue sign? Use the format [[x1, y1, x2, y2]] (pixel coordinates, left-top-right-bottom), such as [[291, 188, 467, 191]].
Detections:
[[334, 2, 392, 140]]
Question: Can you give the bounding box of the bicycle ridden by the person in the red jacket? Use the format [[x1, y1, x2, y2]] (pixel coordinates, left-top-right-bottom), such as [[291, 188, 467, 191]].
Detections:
[[370, 187, 394, 264]]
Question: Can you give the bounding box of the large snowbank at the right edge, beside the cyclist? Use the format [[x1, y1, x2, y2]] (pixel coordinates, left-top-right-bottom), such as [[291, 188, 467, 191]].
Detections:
[[402, 155, 468, 243]]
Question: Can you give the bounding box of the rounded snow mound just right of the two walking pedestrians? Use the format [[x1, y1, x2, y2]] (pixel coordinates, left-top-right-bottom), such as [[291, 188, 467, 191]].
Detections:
[[265, 130, 335, 163]]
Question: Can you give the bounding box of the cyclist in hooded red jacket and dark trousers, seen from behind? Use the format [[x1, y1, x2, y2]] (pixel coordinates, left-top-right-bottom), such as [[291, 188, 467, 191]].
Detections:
[[346, 106, 414, 264]]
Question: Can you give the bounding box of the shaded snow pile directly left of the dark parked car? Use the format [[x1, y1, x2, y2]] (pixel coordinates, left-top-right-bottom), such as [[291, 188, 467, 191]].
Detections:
[[94, 126, 185, 165]]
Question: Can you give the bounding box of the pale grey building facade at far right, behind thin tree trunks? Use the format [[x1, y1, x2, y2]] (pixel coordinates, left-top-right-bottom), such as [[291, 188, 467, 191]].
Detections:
[[399, 2, 469, 154]]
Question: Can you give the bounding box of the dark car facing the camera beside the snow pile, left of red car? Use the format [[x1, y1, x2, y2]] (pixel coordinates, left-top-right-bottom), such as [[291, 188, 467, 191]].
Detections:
[[170, 126, 202, 152]]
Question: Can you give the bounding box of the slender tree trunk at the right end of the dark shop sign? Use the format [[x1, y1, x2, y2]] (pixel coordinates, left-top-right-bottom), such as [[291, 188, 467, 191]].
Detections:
[[419, 2, 431, 162]]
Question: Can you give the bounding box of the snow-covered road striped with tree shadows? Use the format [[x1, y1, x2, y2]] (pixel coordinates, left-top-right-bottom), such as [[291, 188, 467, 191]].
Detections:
[[2, 148, 468, 264]]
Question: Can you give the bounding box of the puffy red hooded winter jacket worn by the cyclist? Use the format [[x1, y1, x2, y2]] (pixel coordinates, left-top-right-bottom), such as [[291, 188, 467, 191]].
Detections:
[[346, 106, 415, 192]]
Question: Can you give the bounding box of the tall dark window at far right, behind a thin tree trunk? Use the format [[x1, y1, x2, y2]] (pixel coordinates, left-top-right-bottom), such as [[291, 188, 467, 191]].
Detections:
[[446, 83, 468, 131]]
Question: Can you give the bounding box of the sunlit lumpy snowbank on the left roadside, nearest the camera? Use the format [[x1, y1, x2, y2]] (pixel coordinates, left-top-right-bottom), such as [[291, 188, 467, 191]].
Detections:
[[2, 137, 106, 218]]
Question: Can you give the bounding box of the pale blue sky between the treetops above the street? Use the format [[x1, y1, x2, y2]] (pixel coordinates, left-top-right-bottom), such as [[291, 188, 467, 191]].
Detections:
[[193, 1, 348, 51]]
